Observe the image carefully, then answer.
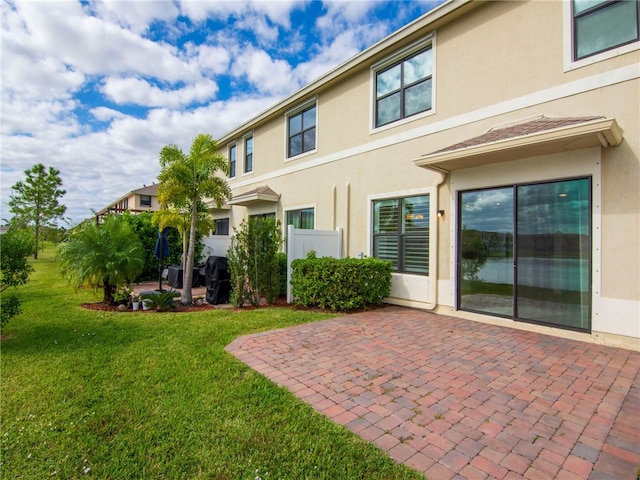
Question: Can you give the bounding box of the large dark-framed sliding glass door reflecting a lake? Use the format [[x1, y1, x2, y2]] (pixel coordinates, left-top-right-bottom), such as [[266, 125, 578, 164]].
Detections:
[[458, 178, 591, 331]]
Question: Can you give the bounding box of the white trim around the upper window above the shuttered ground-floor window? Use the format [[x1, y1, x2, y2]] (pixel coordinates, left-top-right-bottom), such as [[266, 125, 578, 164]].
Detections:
[[369, 32, 437, 133]]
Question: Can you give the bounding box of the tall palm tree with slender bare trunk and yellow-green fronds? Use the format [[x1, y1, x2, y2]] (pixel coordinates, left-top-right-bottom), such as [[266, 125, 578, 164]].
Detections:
[[158, 133, 231, 305]]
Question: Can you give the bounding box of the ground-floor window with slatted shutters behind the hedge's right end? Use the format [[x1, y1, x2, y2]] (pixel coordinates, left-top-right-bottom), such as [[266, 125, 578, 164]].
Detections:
[[373, 195, 429, 275]]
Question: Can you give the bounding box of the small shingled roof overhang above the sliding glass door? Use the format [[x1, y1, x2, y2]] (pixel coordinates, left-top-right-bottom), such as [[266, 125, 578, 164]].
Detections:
[[413, 117, 623, 173]]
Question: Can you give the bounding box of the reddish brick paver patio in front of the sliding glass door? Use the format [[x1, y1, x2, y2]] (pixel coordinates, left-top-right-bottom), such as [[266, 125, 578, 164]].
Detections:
[[227, 307, 640, 480]]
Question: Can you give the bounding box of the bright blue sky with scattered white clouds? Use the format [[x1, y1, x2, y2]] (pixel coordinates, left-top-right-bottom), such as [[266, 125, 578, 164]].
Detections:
[[0, 0, 442, 224]]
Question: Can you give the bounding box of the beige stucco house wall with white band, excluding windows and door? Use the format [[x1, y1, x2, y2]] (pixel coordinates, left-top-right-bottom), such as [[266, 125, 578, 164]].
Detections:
[[213, 1, 640, 349]]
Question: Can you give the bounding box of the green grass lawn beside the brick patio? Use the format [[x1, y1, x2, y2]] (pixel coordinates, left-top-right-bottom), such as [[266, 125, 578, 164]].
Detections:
[[0, 248, 423, 480]]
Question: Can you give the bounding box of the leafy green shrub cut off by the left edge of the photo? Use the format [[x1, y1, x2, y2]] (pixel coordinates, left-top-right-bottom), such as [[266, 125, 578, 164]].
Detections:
[[0, 228, 33, 329]]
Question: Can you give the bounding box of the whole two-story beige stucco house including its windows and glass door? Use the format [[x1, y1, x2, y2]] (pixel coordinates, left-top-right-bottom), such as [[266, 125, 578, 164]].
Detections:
[[213, 0, 640, 348]]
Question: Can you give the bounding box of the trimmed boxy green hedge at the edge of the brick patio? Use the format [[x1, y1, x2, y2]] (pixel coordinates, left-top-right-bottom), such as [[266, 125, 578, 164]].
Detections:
[[291, 255, 392, 311]]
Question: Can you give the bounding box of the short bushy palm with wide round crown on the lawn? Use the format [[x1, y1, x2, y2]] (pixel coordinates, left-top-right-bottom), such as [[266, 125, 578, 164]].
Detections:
[[58, 215, 145, 304]]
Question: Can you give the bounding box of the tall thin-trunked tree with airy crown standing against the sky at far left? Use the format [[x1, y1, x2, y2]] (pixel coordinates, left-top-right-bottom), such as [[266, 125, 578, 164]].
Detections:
[[9, 163, 67, 259]]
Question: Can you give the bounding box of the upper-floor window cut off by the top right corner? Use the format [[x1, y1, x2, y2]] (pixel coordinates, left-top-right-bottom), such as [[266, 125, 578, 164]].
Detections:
[[573, 0, 640, 60]]
